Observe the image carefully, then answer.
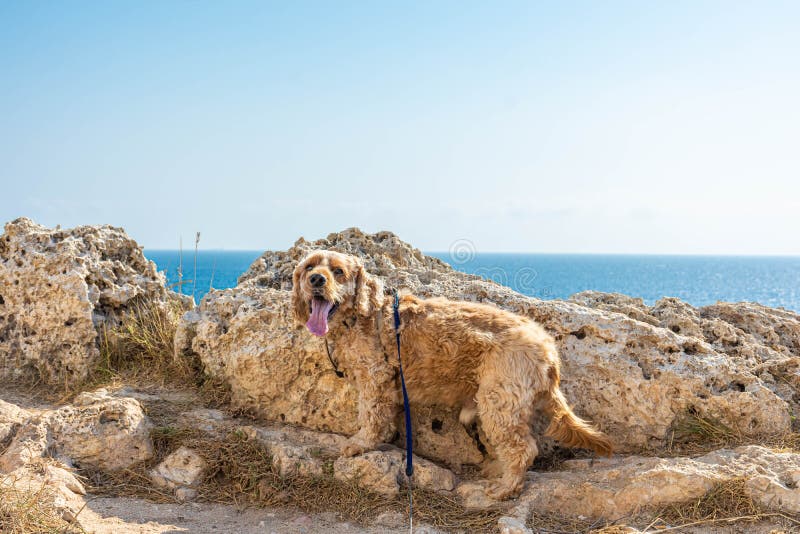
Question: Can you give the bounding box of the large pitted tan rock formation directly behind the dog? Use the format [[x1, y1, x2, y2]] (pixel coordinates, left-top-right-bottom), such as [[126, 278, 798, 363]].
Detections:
[[176, 229, 798, 468]]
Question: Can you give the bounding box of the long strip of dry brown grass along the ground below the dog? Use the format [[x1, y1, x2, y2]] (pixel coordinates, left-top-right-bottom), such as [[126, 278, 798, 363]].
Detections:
[[83, 427, 502, 532]]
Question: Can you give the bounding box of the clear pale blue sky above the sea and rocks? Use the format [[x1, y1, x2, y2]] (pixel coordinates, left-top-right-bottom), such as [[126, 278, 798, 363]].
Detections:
[[0, 0, 800, 254]]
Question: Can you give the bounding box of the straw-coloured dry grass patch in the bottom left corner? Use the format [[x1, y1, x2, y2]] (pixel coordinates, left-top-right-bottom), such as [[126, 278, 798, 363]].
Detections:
[[0, 485, 84, 534]]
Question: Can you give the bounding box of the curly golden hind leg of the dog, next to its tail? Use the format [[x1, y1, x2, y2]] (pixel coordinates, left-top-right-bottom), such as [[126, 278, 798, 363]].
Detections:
[[475, 355, 541, 499]]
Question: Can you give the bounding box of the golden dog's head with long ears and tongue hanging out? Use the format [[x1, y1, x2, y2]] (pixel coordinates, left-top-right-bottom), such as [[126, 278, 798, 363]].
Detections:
[[292, 250, 383, 336]]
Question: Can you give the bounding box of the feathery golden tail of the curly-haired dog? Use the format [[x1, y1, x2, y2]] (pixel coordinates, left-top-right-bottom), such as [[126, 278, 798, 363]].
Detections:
[[545, 388, 613, 456]]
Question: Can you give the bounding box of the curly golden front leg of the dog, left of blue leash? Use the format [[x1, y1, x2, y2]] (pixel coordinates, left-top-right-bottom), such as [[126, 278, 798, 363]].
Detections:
[[342, 358, 398, 456]]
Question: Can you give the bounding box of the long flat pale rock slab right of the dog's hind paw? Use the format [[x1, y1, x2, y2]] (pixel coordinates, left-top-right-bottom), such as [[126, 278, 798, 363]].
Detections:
[[517, 445, 800, 519]]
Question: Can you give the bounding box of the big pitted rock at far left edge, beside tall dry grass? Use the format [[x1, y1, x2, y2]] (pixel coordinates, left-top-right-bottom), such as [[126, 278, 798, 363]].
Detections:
[[0, 218, 184, 384]]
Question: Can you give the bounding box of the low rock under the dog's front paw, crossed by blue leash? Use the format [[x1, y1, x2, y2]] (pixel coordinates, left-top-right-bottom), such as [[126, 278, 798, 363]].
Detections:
[[333, 449, 456, 496]]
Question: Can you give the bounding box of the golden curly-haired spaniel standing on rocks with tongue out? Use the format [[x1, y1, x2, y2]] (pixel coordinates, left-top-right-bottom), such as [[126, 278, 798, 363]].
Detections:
[[292, 251, 612, 500]]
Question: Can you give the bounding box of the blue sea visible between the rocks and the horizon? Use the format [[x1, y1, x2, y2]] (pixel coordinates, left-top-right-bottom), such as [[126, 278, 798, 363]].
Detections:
[[145, 250, 800, 312]]
